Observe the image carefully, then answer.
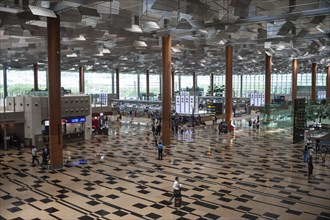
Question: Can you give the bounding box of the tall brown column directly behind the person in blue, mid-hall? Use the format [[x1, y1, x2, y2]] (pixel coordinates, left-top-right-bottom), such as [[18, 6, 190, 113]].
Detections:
[[162, 35, 172, 145]]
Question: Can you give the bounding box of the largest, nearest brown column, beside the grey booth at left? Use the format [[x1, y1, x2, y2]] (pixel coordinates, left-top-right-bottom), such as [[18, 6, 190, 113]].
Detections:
[[47, 17, 63, 169]]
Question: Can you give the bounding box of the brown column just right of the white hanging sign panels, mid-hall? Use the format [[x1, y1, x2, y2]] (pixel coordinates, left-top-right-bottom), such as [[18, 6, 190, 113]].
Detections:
[[225, 45, 233, 131]]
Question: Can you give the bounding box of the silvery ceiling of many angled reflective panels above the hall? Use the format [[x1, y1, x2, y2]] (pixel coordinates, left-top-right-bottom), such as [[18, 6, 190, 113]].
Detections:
[[0, 0, 330, 75]]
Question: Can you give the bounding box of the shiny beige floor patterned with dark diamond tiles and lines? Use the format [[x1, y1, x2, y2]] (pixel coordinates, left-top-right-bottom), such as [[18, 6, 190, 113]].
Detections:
[[0, 120, 330, 220]]
